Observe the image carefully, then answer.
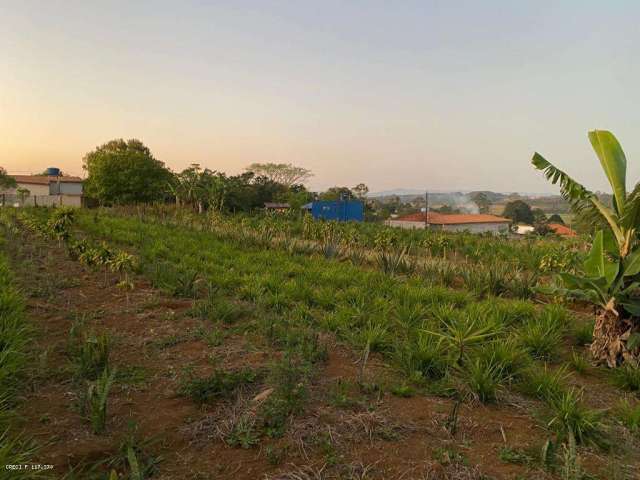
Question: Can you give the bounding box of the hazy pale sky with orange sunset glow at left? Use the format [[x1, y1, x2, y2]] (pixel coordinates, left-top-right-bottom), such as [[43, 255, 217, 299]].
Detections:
[[0, 0, 640, 192]]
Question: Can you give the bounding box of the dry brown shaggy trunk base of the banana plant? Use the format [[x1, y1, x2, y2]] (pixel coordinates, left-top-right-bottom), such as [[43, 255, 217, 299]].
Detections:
[[590, 308, 638, 368]]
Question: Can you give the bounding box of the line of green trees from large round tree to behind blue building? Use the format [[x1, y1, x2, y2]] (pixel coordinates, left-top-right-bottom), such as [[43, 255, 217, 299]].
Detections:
[[83, 139, 368, 212]]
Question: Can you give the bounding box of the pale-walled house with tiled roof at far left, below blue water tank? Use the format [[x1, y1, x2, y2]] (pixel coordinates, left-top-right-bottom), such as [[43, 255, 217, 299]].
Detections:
[[0, 175, 84, 207]]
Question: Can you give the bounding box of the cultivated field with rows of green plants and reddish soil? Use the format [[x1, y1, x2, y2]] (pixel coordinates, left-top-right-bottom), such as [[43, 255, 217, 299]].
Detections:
[[2, 208, 640, 479]]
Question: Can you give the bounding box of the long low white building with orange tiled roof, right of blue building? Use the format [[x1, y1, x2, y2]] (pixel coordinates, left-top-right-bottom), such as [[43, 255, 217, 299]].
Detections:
[[385, 212, 511, 234]]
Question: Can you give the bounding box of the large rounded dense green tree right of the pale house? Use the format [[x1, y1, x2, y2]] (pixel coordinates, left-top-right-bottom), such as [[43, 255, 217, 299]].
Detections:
[[83, 139, 172, 205]]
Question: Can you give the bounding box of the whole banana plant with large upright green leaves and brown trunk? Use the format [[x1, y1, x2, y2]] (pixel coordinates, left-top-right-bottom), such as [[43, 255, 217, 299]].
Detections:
[[532, 130, 640, 367]]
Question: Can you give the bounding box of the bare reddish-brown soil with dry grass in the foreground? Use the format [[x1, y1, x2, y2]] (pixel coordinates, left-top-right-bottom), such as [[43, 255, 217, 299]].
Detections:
[[3, 232, 636, 480]]
